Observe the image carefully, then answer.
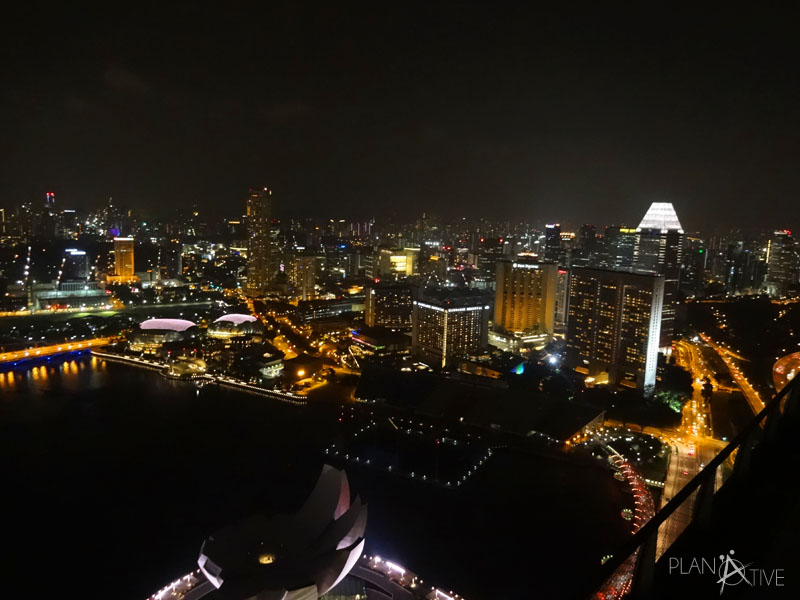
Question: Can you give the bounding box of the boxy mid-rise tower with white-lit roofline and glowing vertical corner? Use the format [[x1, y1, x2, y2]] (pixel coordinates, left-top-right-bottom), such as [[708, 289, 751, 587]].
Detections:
[[411, 290, 490, 368]]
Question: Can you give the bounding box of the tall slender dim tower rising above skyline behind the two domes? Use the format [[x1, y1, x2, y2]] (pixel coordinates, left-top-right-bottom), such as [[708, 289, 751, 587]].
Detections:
[[245, 188, 272, 294]]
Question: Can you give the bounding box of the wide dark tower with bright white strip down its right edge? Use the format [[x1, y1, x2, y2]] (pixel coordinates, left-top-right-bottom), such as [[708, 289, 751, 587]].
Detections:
[[567, 267, 664, 388]]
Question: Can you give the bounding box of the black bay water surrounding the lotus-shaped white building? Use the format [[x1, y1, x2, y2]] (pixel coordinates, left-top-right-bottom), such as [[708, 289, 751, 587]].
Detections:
[[0, 357, 630, 600]]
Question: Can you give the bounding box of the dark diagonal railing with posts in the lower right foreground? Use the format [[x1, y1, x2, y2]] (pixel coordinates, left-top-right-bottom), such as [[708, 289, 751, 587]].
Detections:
[[584, 377, 800, 600]]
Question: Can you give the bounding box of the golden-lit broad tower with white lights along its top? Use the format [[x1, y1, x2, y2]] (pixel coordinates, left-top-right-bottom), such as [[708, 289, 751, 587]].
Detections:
[[494, 258, 557, 335]]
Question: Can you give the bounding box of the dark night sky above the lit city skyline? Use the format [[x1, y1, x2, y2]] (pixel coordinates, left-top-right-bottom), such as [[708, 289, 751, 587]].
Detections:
[[0, 2, 800, 230]]
